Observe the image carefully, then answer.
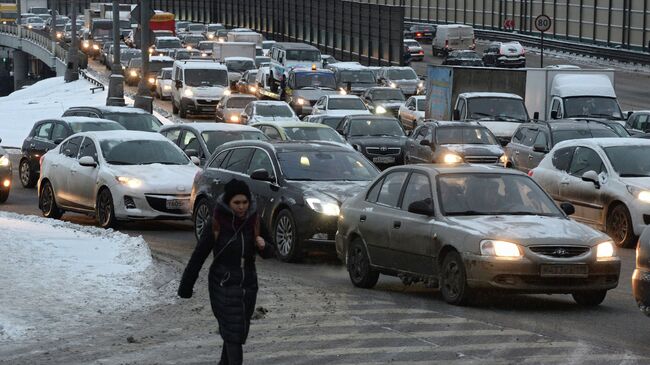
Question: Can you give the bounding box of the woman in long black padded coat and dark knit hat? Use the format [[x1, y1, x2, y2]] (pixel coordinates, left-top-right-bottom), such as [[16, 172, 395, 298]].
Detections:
[[178, 179, 274, 365]]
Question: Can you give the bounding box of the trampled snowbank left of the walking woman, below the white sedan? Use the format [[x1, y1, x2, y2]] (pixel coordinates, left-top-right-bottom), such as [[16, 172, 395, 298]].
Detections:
[[0, 212, 178, 343]]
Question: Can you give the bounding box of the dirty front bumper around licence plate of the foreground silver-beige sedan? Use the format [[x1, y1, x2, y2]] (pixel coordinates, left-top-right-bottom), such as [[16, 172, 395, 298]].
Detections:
[[463, 253, 621, 294]]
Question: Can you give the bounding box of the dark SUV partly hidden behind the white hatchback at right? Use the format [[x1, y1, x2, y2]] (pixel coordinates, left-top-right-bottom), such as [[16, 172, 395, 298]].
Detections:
[[506, 119, 621, 172]]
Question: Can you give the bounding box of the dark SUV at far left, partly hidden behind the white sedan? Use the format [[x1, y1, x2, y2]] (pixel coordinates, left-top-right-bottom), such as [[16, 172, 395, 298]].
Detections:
[[18, 117, 125, 188]]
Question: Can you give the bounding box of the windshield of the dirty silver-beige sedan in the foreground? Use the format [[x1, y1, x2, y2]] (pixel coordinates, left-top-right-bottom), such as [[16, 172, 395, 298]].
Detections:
[[438, 173, 562, 217]]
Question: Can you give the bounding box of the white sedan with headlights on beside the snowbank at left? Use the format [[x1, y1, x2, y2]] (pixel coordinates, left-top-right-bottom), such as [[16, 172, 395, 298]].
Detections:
[[38, 131, 199, 228]]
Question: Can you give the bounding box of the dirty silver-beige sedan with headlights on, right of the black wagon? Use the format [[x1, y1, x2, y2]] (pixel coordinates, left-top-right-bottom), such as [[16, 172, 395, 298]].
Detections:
[[336, 165, 620, 306]]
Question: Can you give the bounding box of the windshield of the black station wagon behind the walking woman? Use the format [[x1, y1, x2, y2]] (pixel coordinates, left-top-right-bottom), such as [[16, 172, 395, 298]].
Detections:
[[278, 151, 377, 181]]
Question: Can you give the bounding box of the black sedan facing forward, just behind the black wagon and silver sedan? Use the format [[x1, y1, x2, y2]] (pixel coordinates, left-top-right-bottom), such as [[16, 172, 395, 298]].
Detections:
[[336, 115, 407, 169]]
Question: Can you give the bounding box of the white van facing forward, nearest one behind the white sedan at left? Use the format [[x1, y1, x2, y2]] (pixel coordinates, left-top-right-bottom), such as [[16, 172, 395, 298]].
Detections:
[[172, 60, 230, 118]]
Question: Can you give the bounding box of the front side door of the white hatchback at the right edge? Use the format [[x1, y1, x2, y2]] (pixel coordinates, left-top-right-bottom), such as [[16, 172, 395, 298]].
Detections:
[[560, 146, 608, 227]]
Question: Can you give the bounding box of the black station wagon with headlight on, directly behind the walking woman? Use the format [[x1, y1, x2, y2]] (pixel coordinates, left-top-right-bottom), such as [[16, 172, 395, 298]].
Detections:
[[191, 141, 379, 261]]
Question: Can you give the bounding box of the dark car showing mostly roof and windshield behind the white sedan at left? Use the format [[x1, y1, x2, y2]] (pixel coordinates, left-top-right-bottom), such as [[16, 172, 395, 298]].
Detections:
[[63, 106, 162, 132]]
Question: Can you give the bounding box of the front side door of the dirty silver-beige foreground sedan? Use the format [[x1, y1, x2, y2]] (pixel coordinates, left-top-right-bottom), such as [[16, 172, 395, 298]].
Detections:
[[390, 172, 440, 275]]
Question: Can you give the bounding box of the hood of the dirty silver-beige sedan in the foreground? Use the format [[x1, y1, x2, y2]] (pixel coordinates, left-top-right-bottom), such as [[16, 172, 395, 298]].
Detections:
[[447, 215, 609, 246]]
